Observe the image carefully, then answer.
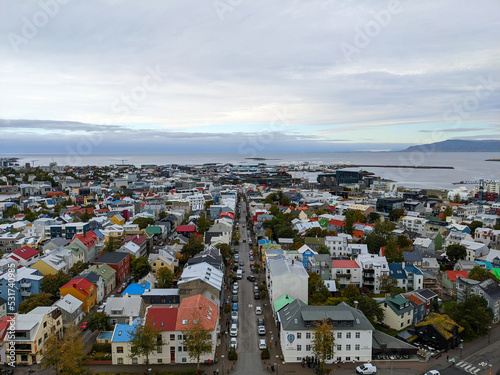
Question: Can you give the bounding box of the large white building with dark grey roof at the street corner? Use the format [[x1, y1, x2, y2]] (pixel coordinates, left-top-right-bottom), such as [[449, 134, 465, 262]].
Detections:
[[277, 299, 374, 364]]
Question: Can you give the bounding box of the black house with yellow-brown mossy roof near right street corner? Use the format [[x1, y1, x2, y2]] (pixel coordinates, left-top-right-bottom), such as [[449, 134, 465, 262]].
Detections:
[[415, 313, 464, 351]]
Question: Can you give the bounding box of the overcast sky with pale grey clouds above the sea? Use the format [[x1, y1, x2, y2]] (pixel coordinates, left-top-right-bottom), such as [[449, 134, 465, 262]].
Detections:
[[0, 0, 500, 153]]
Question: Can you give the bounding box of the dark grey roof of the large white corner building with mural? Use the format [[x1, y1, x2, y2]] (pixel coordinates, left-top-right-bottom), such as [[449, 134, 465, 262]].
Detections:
[[278, 299, 374, 331]]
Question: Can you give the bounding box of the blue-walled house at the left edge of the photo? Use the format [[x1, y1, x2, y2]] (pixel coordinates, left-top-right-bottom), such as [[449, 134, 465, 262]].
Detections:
[[0, 267, 43, 314]]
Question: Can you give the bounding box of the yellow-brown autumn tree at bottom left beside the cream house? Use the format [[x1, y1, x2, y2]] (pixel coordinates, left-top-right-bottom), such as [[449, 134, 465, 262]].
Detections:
[[42, 325, 90, 375]]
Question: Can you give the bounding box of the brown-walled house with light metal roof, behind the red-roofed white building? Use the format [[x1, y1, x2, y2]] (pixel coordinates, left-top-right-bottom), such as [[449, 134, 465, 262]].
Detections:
[[177, 263, 224, 306]]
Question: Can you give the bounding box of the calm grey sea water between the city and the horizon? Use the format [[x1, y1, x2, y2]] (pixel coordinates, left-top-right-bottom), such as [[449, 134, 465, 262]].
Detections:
[[0, 150, 500, 189]]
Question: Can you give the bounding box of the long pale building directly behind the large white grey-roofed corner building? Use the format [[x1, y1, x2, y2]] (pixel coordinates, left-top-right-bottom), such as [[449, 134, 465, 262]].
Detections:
[[266, 257, 309, 314]]
